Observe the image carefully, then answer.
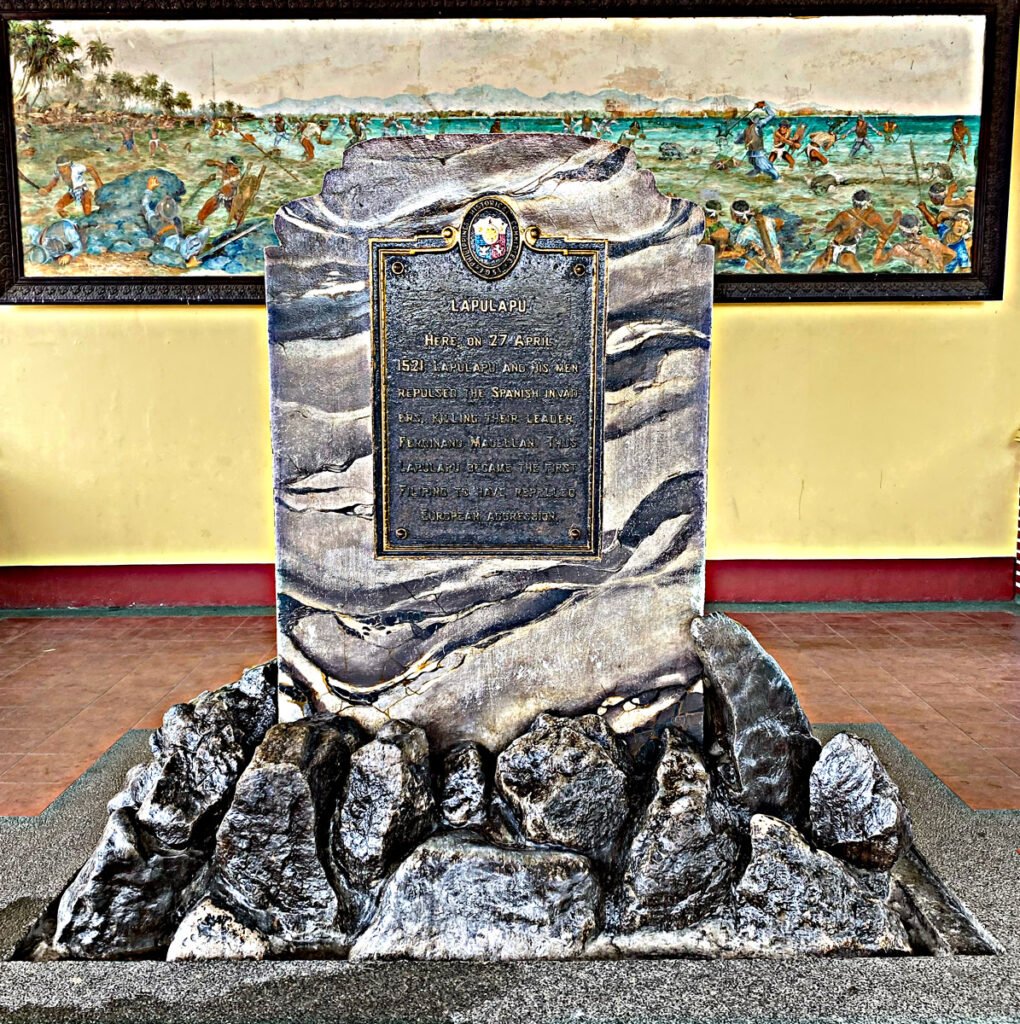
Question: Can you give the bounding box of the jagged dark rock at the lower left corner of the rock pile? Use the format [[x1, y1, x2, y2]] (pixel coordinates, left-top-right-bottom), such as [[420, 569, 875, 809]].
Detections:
[[52, 810, 207, 959]]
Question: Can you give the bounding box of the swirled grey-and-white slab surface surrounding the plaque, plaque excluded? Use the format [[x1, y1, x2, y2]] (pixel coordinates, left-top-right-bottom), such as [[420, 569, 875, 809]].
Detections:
[[266, 135, 712, 749]]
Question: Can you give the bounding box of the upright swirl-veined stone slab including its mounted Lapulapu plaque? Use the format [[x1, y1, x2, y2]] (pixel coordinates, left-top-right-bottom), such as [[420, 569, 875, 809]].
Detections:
[[266, 134, 712, 749]]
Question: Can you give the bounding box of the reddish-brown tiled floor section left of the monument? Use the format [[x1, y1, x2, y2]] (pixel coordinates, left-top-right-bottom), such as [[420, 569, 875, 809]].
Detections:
[[0, 616, 277, 814]]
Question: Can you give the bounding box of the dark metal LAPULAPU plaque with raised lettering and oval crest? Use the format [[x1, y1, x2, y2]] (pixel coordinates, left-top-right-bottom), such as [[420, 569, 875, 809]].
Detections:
[[369, 197, 608, 557]]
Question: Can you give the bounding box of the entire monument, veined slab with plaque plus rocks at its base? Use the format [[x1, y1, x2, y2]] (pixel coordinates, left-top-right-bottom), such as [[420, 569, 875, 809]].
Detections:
[[18, 135, 1000, 961]]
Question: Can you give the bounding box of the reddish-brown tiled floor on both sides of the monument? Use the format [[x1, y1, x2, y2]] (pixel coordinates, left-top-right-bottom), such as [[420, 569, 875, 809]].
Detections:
[[0, 612, 1020, 815]]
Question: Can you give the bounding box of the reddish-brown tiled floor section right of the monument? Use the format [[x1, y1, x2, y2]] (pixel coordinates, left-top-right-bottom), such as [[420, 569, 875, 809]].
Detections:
[[734, 612, 1020, 810]]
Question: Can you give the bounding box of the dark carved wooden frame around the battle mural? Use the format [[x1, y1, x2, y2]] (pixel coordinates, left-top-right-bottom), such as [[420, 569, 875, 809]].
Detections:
[[0, 0, 1020, 304]]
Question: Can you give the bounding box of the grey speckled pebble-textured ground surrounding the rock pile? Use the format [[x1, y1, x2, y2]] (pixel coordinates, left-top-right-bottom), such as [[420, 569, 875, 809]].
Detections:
[[0, 725, 1020, 1024]]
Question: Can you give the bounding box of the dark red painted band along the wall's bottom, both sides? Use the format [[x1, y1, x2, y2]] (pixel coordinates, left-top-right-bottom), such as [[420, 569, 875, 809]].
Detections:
[[0, 557, 1014, 608]]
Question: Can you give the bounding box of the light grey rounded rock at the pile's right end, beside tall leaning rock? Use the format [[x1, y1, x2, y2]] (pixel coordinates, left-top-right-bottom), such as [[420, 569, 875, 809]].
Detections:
[[810, 732, 910, 870]]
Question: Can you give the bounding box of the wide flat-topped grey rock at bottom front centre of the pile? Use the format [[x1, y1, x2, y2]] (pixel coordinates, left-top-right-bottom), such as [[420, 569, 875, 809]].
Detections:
[[350, 833, 599, 961]]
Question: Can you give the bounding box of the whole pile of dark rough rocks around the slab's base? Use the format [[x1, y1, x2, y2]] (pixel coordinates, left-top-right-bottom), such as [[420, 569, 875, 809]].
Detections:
[[25, 615, 979, 961]]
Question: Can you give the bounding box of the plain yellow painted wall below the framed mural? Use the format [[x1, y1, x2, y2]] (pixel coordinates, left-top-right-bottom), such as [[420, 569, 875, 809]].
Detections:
[[0, 101, 1020, 565]]
